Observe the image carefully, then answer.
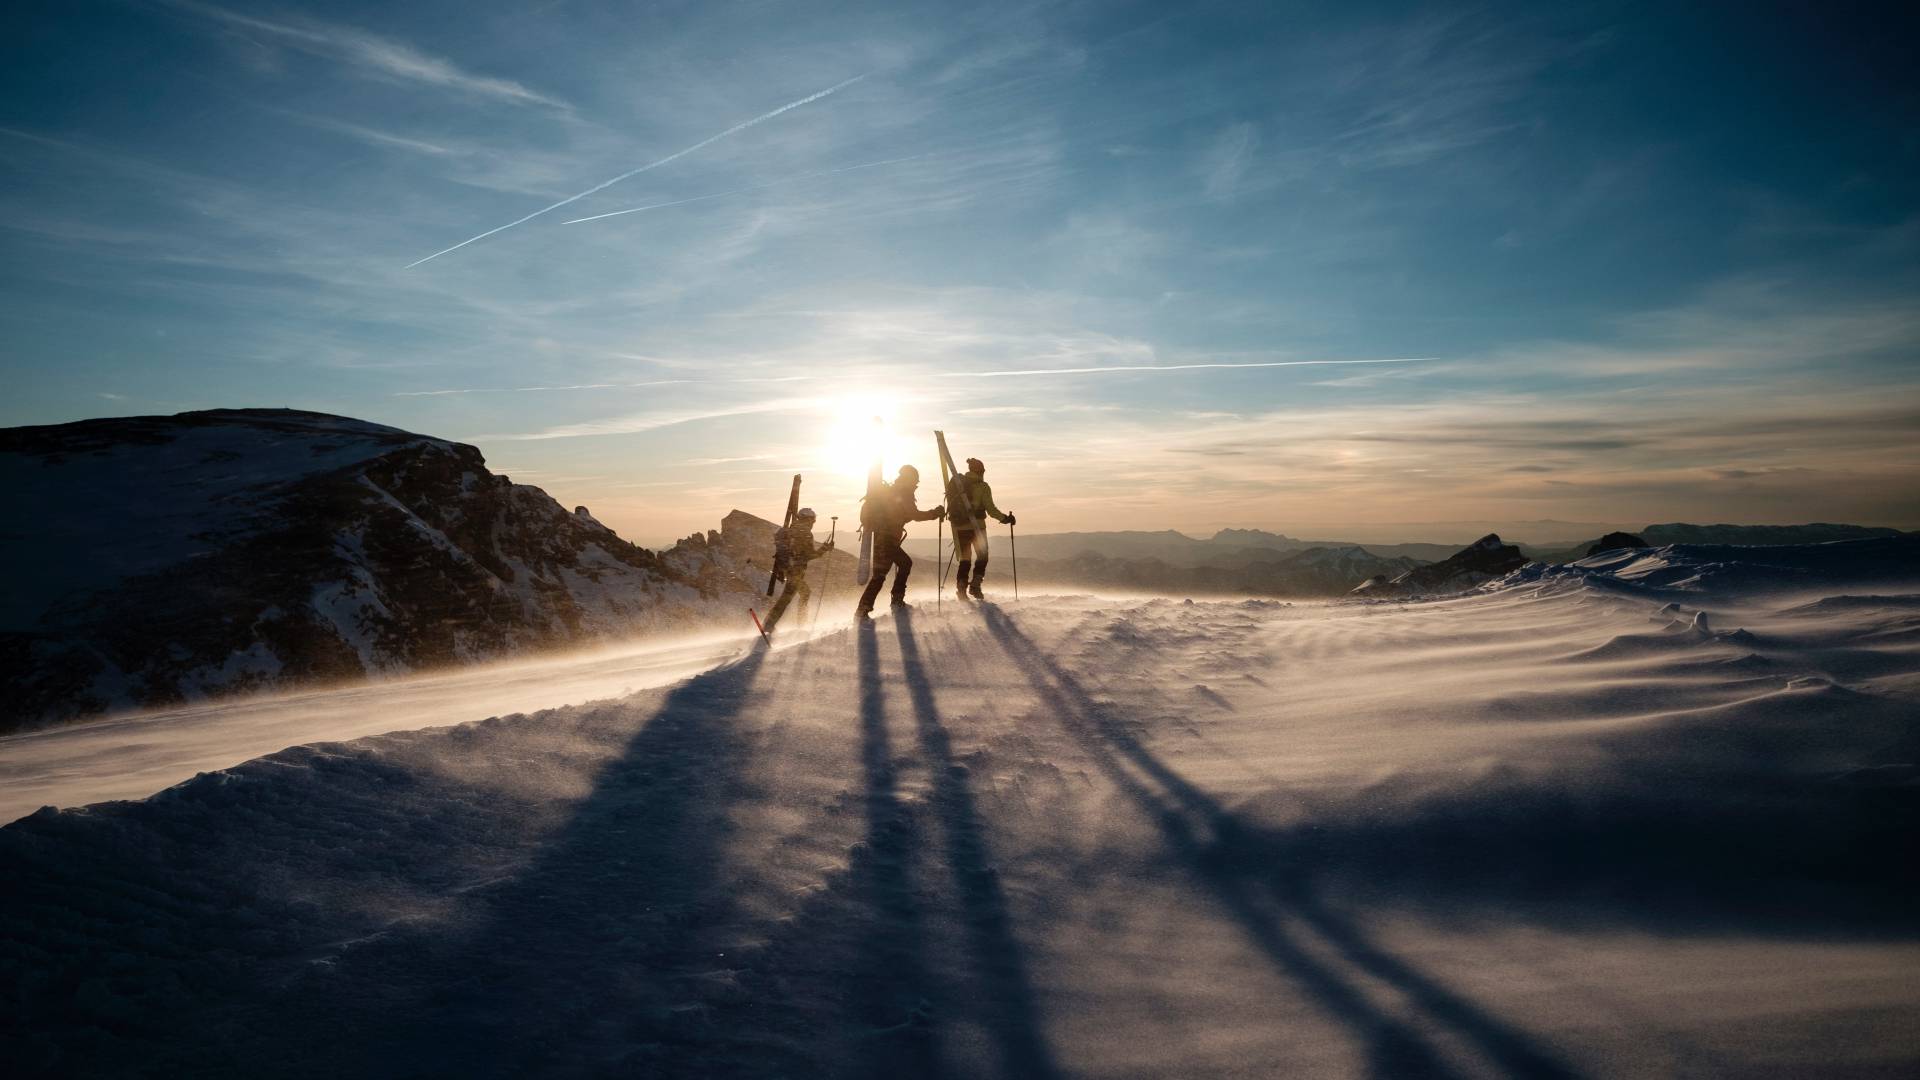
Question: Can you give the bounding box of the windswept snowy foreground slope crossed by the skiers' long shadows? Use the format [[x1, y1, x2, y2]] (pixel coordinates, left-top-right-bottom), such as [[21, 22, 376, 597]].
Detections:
[[0, 568, 1920, 1078]]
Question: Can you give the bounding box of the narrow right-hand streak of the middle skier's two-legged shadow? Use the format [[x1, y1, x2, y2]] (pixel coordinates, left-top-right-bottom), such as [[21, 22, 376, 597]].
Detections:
[[895, 611, 1058, 1080]]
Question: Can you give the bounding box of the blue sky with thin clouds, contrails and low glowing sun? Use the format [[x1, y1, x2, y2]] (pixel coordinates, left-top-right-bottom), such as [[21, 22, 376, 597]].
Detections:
[[0, 0, 1920, 544]]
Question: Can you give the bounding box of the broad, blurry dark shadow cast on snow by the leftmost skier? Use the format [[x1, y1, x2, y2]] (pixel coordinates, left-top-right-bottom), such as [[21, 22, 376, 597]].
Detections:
[[253, 648, 766, 1076]]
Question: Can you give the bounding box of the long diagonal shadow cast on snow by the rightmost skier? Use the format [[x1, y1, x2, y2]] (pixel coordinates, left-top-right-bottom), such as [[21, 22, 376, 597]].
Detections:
[[981, 603, 1574, 1076]]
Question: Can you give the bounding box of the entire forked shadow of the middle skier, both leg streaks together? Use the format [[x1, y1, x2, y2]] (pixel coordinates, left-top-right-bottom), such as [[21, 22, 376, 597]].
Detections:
[[657, 617, 1058, 1080]]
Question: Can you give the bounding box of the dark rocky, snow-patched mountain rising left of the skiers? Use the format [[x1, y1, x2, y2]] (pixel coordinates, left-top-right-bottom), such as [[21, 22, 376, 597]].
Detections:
[[0, 409, 716, 728]]
